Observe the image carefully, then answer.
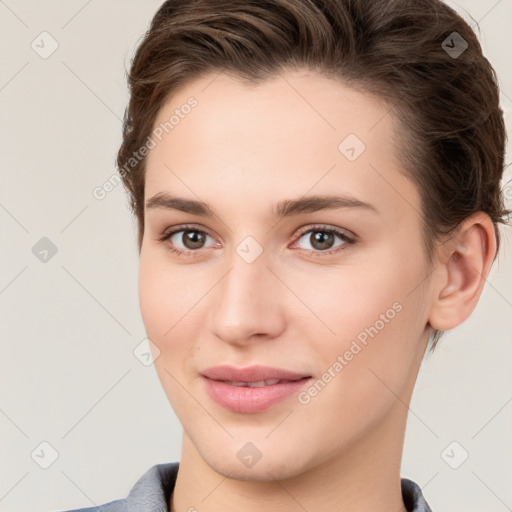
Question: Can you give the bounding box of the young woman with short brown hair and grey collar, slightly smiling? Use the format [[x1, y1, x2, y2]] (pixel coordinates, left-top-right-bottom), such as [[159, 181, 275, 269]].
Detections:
[[59, 0, 508, 512]]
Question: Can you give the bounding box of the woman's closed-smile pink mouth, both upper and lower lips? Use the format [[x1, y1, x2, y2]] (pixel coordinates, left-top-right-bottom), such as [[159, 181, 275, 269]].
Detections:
[[203, 366, 311, 414]]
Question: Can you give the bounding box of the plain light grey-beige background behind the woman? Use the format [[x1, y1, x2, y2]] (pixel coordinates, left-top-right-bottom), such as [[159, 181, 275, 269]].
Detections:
[[0, 0, 512, 512]]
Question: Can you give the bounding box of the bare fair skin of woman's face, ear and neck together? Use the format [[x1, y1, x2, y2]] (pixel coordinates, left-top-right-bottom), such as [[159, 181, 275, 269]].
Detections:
[[139, 69, 496, 512]]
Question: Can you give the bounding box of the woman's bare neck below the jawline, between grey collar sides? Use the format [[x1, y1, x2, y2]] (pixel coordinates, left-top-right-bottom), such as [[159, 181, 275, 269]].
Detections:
[[170, 400, 407, 512]]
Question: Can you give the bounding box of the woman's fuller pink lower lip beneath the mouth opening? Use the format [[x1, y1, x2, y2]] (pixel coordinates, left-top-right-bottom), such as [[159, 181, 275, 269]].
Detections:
[[204, 377, 311, 414]]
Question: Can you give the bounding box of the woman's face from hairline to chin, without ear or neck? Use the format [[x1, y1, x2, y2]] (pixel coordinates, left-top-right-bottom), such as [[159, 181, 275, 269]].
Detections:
[[139, 70, 429, 481]]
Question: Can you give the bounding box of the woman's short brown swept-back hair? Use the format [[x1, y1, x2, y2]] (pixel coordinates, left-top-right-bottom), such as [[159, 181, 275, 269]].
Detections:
[[117, 0, 510, 349]]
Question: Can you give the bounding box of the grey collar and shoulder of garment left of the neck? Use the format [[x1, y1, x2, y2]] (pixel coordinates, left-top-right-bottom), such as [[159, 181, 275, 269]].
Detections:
[[54, 462, 179, 512]]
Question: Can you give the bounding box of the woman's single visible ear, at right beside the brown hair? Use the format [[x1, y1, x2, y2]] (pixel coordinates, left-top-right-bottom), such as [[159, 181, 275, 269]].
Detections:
[[429, 212, 496, 331]]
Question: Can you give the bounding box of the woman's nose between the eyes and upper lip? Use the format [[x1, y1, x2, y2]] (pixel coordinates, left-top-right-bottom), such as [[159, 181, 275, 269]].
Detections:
[[210, 252, 286, 346]]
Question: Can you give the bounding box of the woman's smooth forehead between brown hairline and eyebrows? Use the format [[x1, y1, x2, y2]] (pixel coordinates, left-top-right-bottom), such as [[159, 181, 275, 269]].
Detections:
[[146, 71, 419, 224]]
